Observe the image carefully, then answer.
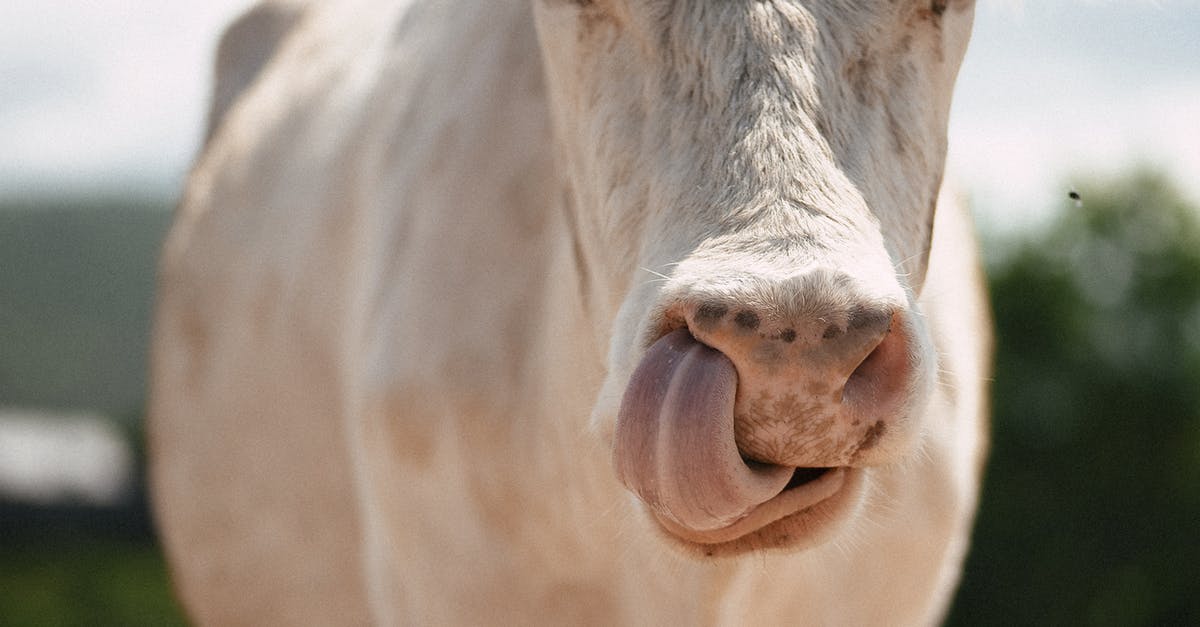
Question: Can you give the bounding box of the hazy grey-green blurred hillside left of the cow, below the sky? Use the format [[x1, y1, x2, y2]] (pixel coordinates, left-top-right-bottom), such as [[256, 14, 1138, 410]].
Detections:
[[0, 198, 170, 416]]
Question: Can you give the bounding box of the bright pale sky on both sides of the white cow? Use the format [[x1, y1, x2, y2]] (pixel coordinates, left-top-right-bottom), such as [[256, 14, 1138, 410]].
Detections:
[[0, 0, 1200, 229]]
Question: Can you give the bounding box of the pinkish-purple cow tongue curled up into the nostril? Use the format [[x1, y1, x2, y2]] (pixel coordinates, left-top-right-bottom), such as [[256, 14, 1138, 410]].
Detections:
[[613, 329, 792, 531]]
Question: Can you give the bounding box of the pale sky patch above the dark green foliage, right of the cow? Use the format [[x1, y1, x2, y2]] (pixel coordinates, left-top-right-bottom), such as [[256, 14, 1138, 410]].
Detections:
[[947, 0, 1200, 231]]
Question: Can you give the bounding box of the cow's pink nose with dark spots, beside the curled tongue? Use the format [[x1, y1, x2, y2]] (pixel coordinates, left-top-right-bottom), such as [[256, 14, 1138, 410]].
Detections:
[[683, 293, 913, 467]]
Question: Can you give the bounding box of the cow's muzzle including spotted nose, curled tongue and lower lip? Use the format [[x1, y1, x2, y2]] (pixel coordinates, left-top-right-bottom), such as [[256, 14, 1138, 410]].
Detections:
[[613, 278, 922, 555]]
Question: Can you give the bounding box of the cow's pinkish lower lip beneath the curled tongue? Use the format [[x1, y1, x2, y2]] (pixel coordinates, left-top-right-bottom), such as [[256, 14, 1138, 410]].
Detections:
[[653, 466, 864, 556]]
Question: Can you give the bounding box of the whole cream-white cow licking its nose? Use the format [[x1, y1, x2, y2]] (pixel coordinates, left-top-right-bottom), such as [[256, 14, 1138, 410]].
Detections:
[[148, 0, 991, 625]]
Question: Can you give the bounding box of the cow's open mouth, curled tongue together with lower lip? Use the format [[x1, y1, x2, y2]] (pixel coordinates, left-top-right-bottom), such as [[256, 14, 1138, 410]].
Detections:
[[613, 329, 864, 555]]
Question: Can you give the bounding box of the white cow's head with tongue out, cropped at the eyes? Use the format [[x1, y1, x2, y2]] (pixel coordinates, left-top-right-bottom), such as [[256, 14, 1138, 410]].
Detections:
[[536, 0, 973, 555]]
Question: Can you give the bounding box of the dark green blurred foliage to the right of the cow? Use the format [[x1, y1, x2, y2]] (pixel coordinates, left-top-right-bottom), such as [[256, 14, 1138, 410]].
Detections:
[[950, 166, 1200, 626]]
